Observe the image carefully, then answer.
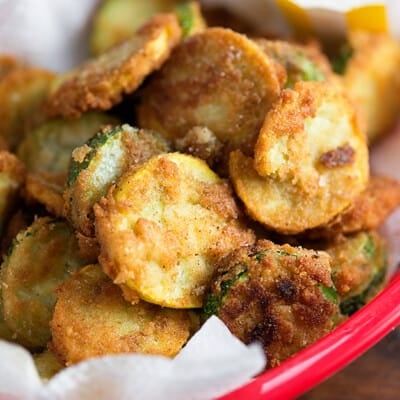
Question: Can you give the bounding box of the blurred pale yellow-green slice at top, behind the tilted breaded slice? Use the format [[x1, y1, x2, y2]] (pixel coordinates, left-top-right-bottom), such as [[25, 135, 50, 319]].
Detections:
[[89, 0, 178, 56]]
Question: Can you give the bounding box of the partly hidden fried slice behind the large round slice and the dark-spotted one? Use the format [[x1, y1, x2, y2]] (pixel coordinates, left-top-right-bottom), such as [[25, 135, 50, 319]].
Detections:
[[254, 38, 334, 88]]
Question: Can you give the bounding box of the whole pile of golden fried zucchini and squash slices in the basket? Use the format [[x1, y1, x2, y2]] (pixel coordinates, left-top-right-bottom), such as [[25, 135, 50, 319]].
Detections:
[[0, 0, 400, 379]]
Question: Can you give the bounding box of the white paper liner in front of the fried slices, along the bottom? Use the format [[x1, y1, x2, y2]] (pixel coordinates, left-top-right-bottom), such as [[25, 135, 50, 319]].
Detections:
[[0, 317, 266, 400]]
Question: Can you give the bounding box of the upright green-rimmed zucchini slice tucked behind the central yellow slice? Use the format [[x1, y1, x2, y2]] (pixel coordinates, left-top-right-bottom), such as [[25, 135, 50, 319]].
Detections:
[[64, 124, 171, 236]]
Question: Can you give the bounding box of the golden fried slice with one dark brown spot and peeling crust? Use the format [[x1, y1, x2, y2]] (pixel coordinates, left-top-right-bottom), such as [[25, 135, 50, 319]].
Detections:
[[229, 82, 369, 234]]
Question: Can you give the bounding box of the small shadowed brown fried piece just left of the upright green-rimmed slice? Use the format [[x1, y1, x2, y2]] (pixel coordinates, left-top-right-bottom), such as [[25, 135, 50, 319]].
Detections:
[[24, 172, 65, 217]]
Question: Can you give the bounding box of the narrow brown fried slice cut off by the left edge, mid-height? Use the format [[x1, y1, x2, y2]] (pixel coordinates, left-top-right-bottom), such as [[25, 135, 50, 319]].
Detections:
[[0, 151, 25, 235]]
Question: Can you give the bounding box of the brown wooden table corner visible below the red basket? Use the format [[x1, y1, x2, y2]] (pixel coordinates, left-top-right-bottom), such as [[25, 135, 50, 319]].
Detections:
[[299, 327, 400, 400]]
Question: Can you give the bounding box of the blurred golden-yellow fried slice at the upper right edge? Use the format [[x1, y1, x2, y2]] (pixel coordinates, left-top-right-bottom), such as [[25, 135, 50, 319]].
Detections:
[[335, 31, 400, 142]]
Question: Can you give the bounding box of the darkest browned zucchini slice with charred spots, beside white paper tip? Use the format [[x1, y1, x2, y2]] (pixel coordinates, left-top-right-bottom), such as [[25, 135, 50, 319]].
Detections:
[[204, 240, 339, 367]]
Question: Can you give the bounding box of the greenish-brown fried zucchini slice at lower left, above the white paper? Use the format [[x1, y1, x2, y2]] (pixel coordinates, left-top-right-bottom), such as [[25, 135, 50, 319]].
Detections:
[[1, 217, 86, 349]]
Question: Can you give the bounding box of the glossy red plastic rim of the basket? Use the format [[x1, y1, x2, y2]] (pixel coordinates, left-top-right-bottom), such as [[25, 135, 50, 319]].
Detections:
[[218, 271, 400, 400]]
